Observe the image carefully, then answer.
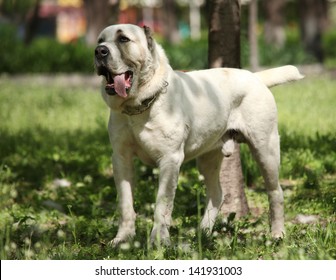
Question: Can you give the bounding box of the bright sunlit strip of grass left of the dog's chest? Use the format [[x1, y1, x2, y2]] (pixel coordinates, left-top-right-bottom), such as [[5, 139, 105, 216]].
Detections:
[[0, 77, 108, 132]]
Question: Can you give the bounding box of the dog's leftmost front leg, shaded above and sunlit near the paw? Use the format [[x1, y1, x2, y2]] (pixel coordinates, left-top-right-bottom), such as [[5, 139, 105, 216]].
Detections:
[[112, 153, 136, 246]]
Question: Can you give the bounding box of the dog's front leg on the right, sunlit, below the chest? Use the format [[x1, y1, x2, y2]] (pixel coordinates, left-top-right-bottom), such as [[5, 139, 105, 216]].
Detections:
[[151, 151, 184, 245]]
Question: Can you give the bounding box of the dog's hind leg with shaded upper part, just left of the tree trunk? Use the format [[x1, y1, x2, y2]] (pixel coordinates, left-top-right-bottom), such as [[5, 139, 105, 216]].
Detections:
[[197, 149, 223, 233]]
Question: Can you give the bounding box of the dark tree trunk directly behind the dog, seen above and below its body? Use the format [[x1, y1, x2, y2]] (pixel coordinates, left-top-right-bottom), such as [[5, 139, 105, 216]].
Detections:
[[208, 0, 249, 217]]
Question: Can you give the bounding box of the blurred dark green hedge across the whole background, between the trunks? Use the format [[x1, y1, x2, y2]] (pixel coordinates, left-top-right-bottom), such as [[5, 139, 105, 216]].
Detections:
[[0, 25, 335, 74]]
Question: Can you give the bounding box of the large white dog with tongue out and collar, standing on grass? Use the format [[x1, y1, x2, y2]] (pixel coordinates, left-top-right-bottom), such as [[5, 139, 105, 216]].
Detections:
[[94, 24, 303, 245]]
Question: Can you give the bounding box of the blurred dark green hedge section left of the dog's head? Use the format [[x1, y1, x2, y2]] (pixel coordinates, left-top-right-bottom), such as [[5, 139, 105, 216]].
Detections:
[[0, 26, 93, 74]]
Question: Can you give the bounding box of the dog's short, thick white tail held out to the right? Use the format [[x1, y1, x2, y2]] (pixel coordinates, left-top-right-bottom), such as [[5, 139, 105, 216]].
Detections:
[[254, 65, 304, 87]]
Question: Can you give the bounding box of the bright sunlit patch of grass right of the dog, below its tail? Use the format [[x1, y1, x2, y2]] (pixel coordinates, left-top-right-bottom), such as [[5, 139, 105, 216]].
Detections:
[[272, 77, 336, 136]]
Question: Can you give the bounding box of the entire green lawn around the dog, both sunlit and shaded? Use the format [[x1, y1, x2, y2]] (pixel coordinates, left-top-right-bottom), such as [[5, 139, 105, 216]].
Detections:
[[0, 77, 336, 259]]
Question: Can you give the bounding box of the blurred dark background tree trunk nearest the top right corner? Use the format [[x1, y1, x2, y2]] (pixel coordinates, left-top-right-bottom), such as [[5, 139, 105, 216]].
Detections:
[[298, 0, 328, 63]]
